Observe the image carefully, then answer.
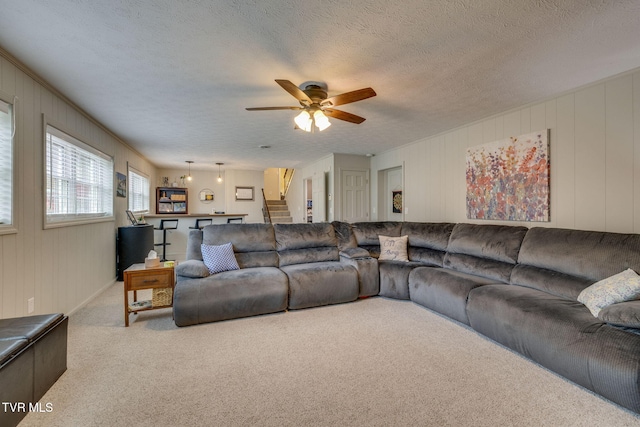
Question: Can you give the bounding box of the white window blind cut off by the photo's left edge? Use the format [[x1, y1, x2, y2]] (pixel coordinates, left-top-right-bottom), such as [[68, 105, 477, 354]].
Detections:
[[0, 101, 13, 227]]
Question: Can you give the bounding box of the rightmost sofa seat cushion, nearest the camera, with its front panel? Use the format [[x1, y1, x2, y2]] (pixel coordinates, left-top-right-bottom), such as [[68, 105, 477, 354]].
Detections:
[[467, 285, 605, 390]]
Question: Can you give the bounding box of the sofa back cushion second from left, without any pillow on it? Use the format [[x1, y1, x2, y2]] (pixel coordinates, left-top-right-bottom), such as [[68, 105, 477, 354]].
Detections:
[[274, 223, 340, 267]]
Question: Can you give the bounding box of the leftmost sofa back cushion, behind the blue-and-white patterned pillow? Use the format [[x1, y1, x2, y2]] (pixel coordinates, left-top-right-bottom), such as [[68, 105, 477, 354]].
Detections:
[[201, 224, 278, 268]]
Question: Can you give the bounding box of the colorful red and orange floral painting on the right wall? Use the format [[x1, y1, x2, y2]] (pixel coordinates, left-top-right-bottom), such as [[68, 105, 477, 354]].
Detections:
[[467, 130, 549, 221]]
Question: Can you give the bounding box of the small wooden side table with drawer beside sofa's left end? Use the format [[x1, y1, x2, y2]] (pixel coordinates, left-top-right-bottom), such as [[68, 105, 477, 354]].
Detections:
[[124, 264, 175, 326]]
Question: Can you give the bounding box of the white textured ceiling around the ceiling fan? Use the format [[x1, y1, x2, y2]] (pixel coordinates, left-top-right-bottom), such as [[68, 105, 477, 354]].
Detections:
[[0, 0, 640, 170]]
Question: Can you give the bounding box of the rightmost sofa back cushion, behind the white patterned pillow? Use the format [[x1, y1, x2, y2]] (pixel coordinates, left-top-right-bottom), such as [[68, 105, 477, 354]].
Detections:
[[511, 227, 640, 300]]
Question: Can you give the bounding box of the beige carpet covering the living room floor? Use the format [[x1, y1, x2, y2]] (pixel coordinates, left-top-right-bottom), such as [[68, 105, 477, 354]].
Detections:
[[20, 282, 640, 427]]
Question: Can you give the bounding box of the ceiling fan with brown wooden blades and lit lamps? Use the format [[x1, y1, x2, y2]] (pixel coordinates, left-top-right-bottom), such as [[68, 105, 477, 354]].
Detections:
[[247, 80, 376, 132]]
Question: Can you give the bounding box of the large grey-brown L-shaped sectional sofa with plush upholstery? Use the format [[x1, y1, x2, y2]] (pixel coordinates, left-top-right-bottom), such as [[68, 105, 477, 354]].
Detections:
[[174, 222, 640, 413]]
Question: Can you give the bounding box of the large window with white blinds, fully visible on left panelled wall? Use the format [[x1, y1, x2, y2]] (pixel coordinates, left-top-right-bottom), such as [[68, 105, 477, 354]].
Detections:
[[45, 125, 113, 225]]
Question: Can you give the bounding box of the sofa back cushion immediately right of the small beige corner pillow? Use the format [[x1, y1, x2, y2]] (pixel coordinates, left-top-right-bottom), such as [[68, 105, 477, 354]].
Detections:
[[400, 222, 455, 267]]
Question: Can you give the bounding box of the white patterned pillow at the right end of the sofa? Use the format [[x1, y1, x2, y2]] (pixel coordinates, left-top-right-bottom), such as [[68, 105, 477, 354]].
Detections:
[[578, 268, 640, 317]]
